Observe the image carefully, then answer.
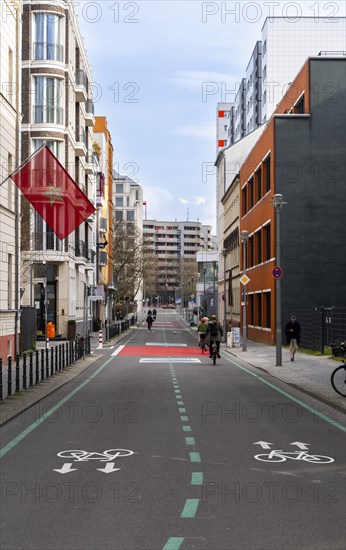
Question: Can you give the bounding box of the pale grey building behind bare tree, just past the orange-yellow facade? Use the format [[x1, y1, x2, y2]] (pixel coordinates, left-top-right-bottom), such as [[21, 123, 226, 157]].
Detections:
[[113, 170, 143, 313]]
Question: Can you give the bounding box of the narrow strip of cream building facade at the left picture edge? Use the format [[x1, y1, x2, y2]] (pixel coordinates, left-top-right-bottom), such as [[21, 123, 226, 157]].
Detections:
[[0, 0, 21, 359]]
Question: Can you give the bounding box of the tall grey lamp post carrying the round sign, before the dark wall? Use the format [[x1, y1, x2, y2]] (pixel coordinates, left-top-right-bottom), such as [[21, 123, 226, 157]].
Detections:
[[273, 193, 284, 367]]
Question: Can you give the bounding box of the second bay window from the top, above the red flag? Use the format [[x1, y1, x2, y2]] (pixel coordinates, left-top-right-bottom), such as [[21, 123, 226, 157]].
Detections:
[[34, 76, 63, 124]]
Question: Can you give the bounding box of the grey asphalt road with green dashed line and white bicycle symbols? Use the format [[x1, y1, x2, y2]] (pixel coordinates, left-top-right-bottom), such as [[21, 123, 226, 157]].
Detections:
[[0, 312, 346, 550]]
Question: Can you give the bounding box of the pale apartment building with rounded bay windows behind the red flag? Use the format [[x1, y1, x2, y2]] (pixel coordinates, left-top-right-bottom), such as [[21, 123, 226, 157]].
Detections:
[[21, 0, 97, 336]]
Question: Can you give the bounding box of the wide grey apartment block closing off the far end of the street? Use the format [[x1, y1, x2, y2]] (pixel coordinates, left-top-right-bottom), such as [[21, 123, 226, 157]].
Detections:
[[143, 220, 214, 304]]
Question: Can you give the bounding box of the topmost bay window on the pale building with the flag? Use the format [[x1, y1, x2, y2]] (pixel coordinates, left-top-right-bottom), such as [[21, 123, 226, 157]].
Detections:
[[33, 13, 63, 61]]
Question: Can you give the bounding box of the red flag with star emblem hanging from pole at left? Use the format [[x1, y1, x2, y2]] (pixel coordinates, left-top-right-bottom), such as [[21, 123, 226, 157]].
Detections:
[[11, 146, 95, 239]]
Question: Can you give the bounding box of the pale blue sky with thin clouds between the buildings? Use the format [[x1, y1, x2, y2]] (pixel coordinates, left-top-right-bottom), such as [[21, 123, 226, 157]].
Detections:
[[74, 0, 345, 234]]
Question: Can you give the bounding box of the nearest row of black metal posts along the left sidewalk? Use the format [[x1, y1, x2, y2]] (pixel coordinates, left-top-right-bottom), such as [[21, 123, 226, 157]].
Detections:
[[0, 336, 90, 401]]
